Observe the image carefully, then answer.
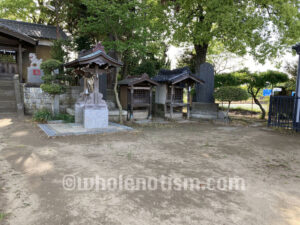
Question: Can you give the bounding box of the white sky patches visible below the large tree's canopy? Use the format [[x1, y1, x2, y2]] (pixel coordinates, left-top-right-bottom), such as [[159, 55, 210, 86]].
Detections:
[[167, 46, 298, 72]]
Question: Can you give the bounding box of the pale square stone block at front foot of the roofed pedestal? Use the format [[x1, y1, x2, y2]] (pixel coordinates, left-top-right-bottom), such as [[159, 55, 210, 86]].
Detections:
[[83, 106, 108, 129]]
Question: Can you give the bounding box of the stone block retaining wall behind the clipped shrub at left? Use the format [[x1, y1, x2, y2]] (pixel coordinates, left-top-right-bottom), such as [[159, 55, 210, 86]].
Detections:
[[21, 84, 81, 114]]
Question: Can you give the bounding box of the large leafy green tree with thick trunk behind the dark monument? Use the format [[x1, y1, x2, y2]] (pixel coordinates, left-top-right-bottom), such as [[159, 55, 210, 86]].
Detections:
[[167, 0, 300, 73]]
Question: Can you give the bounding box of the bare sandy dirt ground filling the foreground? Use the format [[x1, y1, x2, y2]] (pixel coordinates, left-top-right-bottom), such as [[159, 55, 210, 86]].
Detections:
[[0, 116, 300, 225]]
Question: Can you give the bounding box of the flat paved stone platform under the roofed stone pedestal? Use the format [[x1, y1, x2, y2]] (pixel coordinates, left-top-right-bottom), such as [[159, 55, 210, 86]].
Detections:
[[38, 123, 133, 137]]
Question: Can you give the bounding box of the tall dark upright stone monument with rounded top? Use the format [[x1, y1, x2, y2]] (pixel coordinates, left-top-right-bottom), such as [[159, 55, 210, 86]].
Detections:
[[196, 63, 215, 103]]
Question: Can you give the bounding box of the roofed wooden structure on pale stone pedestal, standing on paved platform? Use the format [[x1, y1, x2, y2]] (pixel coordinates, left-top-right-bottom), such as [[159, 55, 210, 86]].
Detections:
[[65, 43, 122, 128]]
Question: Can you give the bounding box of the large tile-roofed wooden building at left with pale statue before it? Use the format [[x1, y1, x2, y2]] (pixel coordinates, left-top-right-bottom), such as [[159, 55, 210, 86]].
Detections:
[[0, 19, 67, 83]]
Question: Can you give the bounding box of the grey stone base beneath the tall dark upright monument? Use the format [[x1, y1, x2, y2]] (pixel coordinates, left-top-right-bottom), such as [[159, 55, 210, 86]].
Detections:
[[191, 102, 220, 119]]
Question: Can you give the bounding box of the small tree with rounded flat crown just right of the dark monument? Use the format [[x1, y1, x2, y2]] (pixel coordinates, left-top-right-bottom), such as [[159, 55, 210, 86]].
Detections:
[[214, 86, 249, 118]]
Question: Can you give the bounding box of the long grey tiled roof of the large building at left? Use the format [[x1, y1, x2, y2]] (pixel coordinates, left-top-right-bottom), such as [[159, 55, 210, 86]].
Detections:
[[0, 19, 67, 40]]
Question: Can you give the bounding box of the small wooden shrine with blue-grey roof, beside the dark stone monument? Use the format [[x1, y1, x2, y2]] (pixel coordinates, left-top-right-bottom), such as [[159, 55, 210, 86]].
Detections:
[[152, 67, 204, 118]]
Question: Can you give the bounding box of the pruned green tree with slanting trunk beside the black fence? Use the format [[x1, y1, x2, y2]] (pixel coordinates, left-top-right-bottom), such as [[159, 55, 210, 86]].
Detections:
[[243, 70, 288, 119]]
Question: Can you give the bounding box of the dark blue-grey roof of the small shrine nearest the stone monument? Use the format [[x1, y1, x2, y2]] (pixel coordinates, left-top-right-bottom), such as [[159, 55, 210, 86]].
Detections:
[[152, 67, 205, 84]]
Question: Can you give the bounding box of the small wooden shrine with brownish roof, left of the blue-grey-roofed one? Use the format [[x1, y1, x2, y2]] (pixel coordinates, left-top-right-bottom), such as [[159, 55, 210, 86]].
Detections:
[[119, 74, 158, 120]]
